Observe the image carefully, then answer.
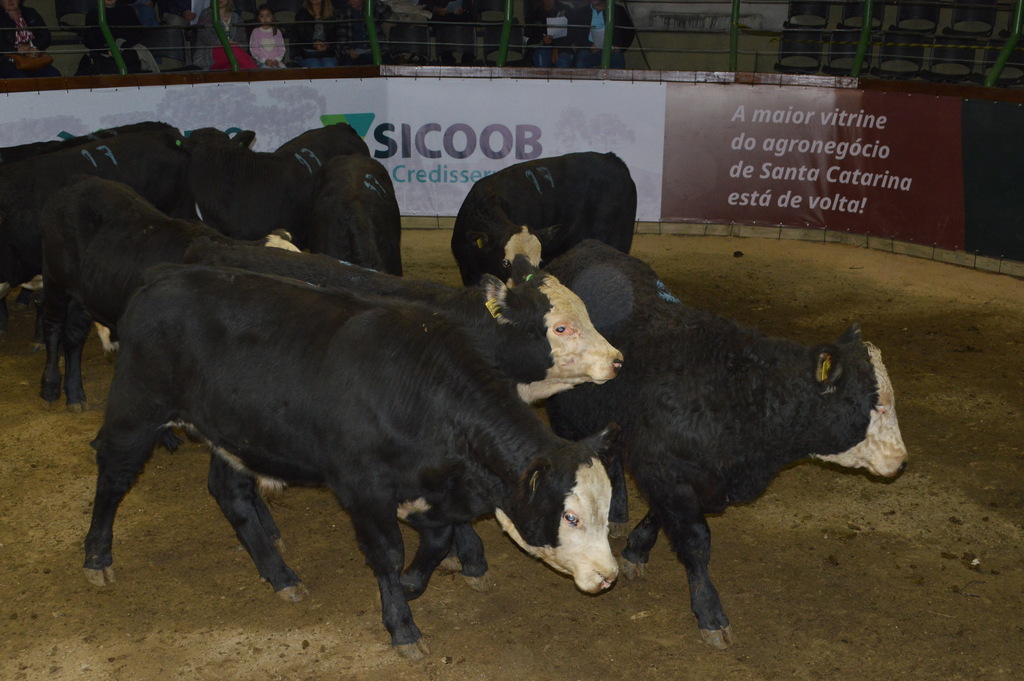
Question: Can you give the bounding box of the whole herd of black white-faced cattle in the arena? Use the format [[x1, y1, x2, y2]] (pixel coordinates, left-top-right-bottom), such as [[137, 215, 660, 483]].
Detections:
[[0, 123, 906, 658]]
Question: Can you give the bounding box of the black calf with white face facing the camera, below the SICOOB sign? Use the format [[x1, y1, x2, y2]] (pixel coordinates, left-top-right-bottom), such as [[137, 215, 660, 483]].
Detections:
[[452, 152, 637, 285]]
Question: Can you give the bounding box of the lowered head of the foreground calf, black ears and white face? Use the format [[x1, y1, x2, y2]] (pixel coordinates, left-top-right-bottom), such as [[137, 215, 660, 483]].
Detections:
[[495, 427, 618, 593]]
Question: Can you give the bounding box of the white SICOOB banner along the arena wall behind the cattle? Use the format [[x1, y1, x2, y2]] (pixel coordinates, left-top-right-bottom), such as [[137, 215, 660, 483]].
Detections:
[[0, 78, 666, 220]]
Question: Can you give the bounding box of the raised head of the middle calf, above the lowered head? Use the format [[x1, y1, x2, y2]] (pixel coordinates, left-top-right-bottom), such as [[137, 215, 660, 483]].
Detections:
[[482, 265, 623, 402]]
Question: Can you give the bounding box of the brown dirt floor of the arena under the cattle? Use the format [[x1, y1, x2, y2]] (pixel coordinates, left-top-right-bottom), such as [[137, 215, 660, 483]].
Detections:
[[0, 230, 1024, 681]]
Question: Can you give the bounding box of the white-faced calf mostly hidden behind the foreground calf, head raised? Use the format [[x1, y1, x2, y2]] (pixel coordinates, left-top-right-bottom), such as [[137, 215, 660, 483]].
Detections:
[[184, 241, 623, 402]]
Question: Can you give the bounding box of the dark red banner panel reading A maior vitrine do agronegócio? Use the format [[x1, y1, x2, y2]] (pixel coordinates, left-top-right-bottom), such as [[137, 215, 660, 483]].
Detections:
[[662, 84, 964, 249]]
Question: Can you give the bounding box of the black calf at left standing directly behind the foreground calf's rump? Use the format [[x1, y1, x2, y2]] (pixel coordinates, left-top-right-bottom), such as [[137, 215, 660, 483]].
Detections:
[[40, 175, 297, 412]]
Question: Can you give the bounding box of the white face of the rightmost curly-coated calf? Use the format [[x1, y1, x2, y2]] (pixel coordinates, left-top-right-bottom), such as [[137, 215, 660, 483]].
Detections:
[[815, 343, 906, 477]]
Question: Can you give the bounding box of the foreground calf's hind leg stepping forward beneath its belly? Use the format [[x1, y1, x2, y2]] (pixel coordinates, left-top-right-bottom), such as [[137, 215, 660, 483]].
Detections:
[[207, 455, 308, 601]]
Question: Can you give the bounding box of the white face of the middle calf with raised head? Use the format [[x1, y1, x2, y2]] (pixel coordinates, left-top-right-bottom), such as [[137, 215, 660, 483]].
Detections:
[[517, 274, 623, 402]]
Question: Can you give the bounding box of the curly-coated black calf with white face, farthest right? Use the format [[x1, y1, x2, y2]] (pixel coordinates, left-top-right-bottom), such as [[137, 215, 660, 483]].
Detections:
[[547, 242, 906, 647]]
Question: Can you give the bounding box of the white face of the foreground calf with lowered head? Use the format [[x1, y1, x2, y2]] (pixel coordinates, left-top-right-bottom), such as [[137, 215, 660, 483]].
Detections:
[[495, 459, 618, 593]]
